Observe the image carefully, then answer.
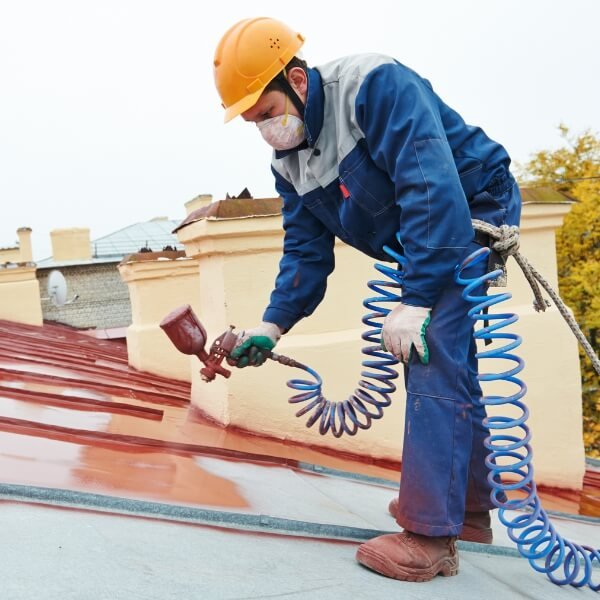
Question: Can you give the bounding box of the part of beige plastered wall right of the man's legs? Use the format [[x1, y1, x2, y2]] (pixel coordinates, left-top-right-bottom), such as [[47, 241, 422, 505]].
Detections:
[[480, 203, 585, 489]]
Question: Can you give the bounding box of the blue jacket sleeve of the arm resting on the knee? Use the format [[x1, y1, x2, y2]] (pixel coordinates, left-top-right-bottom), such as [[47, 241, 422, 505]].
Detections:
[[355, 63, 474, 307]]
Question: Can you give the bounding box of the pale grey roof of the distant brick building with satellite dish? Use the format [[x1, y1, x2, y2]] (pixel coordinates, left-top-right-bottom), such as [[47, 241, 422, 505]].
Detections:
[[37, 218, 183, 269]]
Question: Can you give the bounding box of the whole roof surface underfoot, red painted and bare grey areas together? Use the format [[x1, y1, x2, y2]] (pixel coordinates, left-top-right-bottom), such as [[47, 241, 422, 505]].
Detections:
[[0, 321, 600, 600]]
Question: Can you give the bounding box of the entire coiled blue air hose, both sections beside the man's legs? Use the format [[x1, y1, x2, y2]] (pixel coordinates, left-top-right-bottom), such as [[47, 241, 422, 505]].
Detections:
[[287, 237, 600, 591]]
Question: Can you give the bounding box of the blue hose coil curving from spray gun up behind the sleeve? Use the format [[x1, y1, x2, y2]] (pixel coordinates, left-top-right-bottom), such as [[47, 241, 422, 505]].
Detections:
[[287, 237, 406, 438]]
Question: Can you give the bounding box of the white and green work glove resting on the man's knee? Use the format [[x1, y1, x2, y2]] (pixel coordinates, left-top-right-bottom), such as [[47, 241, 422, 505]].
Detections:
[[381, 303, 431, 365]]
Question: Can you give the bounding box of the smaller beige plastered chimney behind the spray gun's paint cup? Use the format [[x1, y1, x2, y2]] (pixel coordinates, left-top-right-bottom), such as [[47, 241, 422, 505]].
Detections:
[[119, 253, 200, 381]]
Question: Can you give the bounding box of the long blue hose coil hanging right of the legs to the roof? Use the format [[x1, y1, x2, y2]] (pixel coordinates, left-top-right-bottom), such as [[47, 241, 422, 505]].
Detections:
[[455, 248, 600, 592]]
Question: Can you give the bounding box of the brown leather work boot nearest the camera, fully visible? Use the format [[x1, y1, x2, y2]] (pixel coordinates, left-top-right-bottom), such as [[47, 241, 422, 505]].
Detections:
[[356, 531, 458, 581]]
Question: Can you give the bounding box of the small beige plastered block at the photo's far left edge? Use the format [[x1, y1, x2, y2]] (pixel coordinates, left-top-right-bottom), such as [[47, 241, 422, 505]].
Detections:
[[0, 263, 43, 325]]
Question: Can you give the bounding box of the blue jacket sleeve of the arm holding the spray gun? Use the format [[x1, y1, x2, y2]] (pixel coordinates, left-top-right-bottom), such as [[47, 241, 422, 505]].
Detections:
[[263, 169, 335, 331]]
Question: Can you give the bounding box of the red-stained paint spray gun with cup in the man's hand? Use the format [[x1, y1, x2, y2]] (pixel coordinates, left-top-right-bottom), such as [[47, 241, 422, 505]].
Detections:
[[160, 304, 306, 382]]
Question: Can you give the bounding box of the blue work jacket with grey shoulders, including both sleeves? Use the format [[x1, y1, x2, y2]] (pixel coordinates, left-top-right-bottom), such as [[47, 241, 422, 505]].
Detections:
[[263, 54, 520, 330]]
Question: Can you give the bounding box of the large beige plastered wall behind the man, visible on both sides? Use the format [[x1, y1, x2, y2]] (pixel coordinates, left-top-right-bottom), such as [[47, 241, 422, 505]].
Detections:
[[171, 204, 585, 489]]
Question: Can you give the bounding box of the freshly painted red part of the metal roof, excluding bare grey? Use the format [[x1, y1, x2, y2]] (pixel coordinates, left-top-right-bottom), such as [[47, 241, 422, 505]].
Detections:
[[0, 321, 600, 516]]
